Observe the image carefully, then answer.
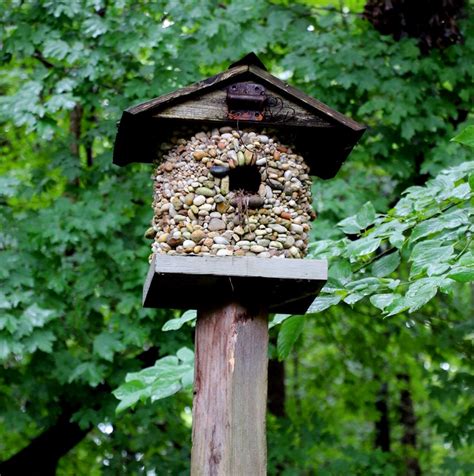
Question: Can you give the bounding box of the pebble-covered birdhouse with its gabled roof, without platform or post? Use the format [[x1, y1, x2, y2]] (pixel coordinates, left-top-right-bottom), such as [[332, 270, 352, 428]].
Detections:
[[114, 54, 365, 264]]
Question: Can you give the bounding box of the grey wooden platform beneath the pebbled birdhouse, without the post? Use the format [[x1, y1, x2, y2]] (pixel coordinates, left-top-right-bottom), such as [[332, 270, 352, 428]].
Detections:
[[143, 255, 327, 314]]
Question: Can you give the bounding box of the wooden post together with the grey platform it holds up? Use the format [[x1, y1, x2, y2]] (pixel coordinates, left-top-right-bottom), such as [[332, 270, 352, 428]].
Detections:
[[143, 255, 327, 476]]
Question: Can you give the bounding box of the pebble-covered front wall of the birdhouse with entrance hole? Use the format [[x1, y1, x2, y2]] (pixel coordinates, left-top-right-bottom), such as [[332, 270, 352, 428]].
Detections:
[[145, 127, 315, 259]]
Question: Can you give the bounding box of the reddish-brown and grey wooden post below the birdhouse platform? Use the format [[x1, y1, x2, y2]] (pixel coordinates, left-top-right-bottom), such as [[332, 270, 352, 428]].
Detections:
[[191, 302, 268, 476]]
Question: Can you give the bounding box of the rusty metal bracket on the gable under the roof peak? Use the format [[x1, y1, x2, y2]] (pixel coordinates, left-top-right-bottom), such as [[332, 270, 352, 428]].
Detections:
[[227, 82, 267, 121]]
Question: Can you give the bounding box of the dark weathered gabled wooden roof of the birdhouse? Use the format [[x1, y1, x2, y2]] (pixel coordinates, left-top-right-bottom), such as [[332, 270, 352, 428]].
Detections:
[[114, 53, 365, 178]]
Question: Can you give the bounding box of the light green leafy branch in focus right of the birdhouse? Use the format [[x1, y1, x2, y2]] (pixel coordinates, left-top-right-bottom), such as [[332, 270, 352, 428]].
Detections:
[[308, 162, 474, 316]]
